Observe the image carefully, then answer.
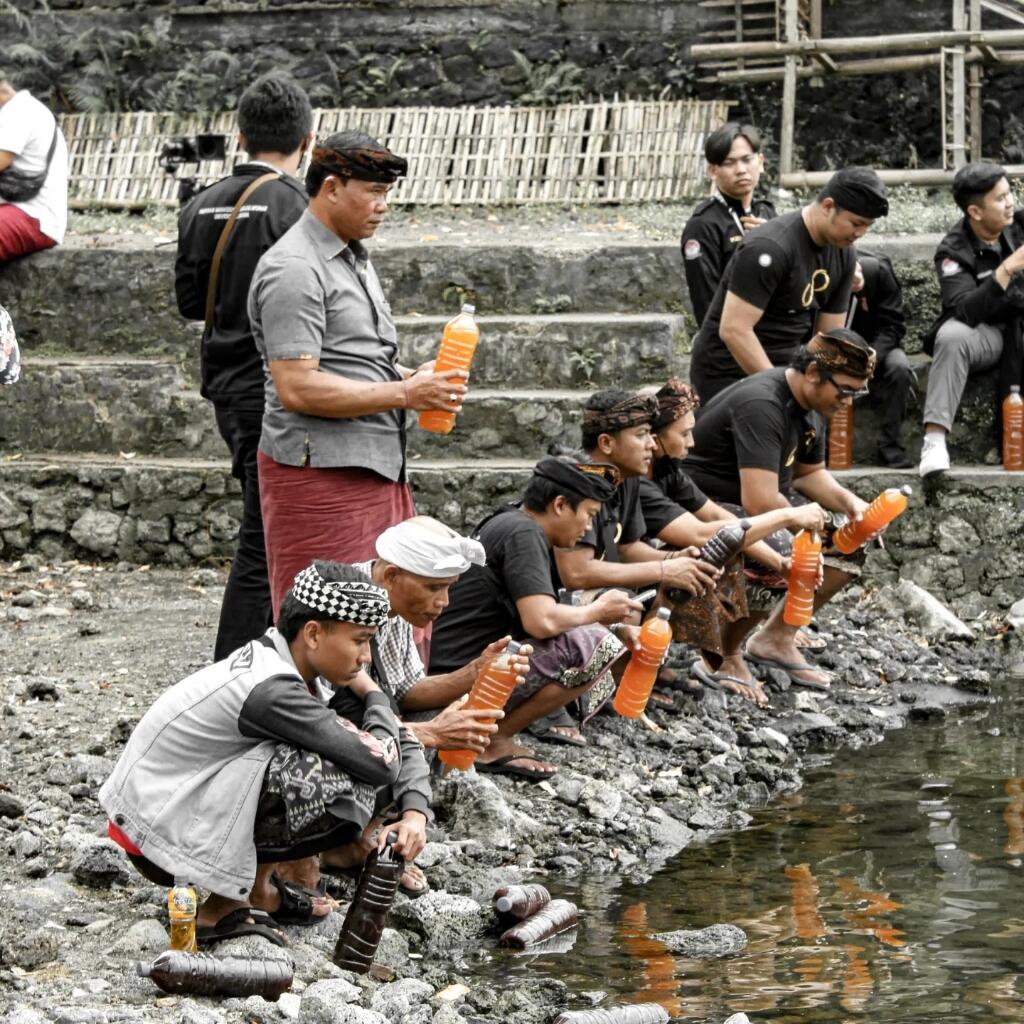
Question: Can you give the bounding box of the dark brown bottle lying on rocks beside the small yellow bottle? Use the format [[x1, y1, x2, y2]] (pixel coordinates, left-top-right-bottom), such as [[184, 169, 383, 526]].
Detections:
[[135, 949, 292, 1002]]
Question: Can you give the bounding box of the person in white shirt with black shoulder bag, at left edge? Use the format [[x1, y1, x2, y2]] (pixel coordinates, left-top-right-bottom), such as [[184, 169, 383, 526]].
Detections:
[[0, 72, 68, 264]]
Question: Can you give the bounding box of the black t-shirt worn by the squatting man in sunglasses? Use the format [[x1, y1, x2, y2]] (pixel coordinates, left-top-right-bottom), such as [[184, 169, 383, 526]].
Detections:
[[682, 367, 825, 505]]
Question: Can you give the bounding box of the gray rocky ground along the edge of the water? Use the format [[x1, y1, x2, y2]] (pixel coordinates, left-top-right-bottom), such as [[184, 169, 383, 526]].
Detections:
[[0, 558, 1024, 1024]]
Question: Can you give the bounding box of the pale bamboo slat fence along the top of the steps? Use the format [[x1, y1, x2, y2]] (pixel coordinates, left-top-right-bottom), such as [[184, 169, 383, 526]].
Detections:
[[60, 99, 729, 208]]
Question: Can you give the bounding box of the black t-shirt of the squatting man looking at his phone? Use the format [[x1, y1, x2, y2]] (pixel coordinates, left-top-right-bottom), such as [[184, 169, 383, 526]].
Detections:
[[430, 508, 558, 673]]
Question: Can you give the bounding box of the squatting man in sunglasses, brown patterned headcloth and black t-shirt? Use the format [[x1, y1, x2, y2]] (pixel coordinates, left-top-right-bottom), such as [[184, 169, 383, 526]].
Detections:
[[682, 328, 874, 689]]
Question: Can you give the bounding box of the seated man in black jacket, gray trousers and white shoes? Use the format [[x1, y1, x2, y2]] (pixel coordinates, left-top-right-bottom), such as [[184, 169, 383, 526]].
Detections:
[[919, 161, 1024, 476]]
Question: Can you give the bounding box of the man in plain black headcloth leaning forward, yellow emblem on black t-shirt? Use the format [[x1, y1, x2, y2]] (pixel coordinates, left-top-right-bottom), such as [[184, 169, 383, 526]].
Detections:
[[690, 167, 889, 403]]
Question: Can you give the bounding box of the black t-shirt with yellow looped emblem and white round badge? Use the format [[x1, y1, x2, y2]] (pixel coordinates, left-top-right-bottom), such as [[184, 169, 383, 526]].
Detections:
[[690, 210, 856, 380]]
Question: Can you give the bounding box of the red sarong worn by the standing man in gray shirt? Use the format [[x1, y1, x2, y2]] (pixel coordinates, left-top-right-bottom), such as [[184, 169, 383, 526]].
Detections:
[[257, 452, 416, 621]]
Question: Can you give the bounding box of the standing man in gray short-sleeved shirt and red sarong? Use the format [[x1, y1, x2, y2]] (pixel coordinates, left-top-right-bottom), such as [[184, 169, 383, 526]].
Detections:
[[249, 131, 466, 615]]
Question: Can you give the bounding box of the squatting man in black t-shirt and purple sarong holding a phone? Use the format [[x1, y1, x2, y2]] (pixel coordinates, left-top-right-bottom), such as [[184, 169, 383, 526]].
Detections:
[[425, 457, 641, 779]]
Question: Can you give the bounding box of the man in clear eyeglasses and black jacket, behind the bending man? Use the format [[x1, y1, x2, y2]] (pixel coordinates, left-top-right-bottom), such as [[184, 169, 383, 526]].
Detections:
[[682, 121, 776, 326]]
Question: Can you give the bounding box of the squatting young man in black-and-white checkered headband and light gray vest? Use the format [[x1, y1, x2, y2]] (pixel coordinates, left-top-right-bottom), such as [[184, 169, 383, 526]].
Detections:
[[99, 561, 430, 945]]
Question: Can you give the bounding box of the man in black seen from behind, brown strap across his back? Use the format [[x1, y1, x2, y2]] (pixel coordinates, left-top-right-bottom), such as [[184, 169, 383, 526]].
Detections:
[[174, 72, 313, 662]]
